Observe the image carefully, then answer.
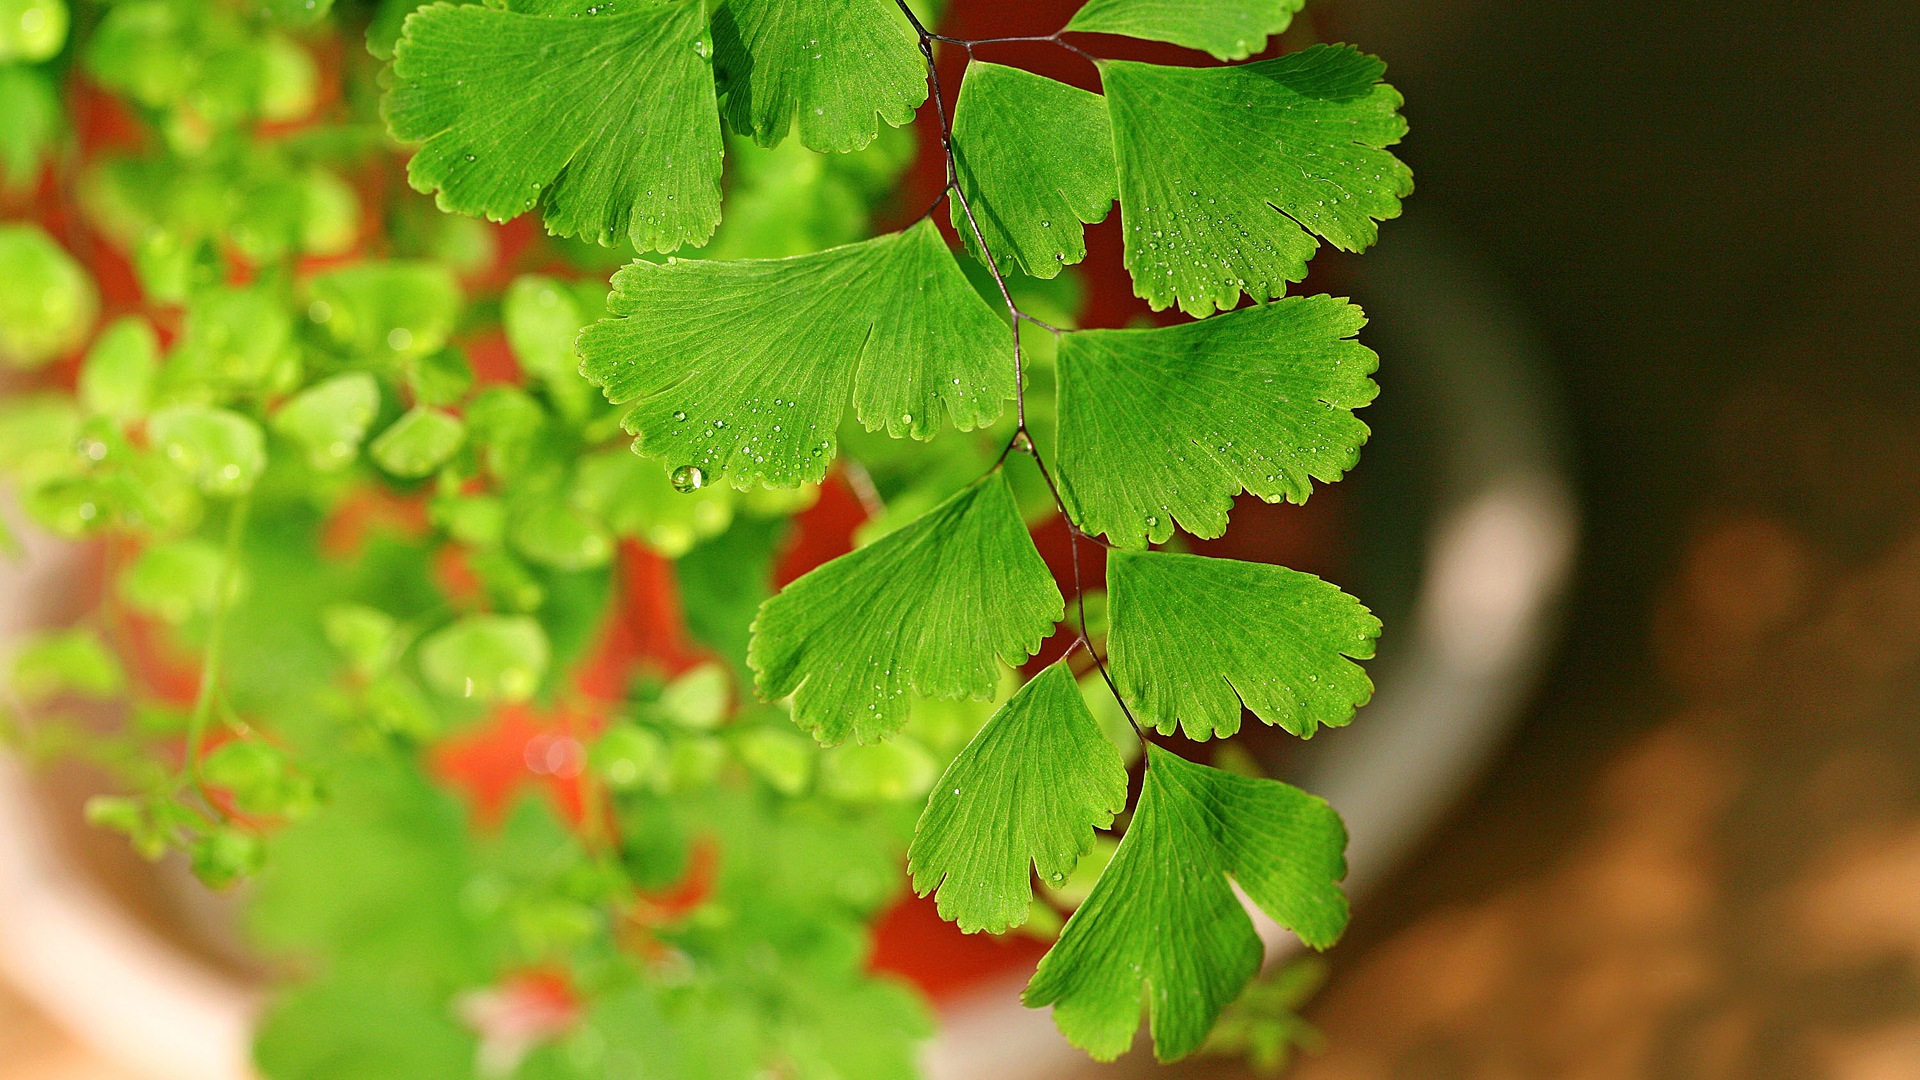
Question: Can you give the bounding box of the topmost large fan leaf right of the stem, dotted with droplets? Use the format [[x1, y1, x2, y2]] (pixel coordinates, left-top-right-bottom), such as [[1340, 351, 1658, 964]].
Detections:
[[1100, 46, 1413, 315]]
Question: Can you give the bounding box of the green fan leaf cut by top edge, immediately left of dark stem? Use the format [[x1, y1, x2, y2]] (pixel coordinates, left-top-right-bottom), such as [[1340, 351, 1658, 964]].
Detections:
[[712, 0, 927, 152]]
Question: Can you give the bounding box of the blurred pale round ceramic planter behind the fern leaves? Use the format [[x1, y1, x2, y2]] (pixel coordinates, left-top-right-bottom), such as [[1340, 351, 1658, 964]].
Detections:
[[0, 213, 1578, 1080]]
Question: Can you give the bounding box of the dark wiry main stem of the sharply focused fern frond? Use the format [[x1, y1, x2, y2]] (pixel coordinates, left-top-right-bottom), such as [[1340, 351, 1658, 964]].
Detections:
[[895, 0, 1146, 744]]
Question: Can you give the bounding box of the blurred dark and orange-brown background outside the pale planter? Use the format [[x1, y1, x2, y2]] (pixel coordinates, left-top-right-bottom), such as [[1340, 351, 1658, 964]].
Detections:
[[0, 0, 1920, 1080]]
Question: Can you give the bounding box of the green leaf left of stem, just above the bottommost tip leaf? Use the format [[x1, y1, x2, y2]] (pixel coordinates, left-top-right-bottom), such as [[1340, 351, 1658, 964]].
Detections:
[[906, 661, 1127, 934]]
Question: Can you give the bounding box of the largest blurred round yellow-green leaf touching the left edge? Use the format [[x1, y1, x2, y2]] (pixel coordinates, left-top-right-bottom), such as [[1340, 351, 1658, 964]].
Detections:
[[0, 220, 100, 367]]
